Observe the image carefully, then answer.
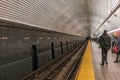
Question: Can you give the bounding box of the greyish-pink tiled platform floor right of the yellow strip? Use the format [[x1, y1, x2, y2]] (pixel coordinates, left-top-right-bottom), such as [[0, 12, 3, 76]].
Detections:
[[91, 42, 120, 80]]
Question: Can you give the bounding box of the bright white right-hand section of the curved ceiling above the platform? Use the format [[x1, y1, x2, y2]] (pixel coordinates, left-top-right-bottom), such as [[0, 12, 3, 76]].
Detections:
[[89, 0, 120, 34]]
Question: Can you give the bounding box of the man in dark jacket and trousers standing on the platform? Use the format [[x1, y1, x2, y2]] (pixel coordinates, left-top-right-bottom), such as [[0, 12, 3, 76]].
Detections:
[[99, 30, 111, 65]]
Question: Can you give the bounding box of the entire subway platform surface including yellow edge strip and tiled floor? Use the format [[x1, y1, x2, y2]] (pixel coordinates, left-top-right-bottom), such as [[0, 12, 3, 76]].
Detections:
[[75, 42, 120, 80]]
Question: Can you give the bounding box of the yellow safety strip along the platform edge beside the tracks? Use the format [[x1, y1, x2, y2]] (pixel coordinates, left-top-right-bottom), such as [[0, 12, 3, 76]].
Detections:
[[75, 41, 95, 80]]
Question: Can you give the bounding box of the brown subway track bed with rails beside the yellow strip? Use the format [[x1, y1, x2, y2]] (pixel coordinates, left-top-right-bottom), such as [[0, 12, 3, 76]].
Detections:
[[21, 43, 87, 80]]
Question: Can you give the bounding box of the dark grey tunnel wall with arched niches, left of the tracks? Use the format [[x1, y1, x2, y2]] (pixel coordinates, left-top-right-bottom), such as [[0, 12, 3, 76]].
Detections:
[[0, 21, 84, 80]]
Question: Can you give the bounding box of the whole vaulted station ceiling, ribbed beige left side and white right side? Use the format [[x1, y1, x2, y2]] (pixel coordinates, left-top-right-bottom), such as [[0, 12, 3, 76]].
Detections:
[[0, 0, 120, 37]]
